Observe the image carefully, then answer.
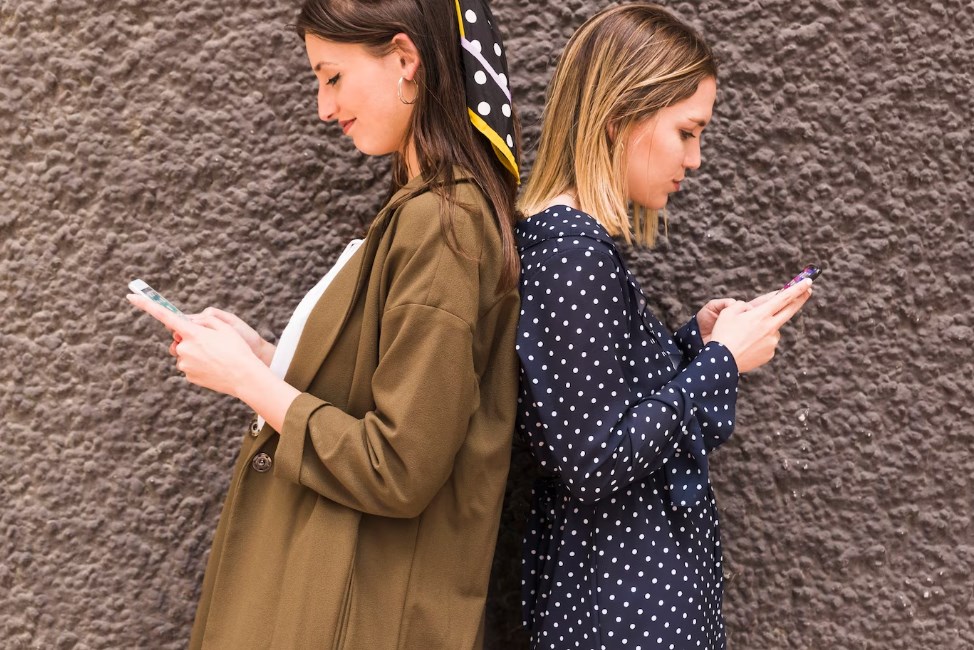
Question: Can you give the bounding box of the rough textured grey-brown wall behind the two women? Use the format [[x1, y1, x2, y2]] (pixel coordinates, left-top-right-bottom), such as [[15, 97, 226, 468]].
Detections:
[[0, 0, 974, 650]]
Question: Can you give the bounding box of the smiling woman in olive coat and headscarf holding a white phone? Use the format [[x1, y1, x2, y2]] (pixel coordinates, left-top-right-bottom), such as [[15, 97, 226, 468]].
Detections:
[[131, 0, 518, 650]]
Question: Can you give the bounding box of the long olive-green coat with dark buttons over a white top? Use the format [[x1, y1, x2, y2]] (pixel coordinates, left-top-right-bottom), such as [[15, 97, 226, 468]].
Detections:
[[190, 175, 519, 650]]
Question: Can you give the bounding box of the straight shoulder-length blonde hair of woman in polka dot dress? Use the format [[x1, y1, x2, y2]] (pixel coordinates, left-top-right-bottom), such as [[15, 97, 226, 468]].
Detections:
[[520, 3, 717, 246]]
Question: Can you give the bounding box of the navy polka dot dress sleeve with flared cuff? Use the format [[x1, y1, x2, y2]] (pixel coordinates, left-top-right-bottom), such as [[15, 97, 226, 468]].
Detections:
[[518, 249, 738, 505]]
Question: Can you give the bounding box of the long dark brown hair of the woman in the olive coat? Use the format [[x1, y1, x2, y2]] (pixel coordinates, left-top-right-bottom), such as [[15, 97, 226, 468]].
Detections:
[[295, 0, 520, 290]]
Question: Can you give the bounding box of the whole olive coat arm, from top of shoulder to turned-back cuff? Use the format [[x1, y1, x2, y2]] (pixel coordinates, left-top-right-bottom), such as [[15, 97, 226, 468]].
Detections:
[[275, 192, 488, 517]]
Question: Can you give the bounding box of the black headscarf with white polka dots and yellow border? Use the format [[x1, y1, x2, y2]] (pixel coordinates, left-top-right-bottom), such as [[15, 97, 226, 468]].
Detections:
[[455, 0, 520, 182]]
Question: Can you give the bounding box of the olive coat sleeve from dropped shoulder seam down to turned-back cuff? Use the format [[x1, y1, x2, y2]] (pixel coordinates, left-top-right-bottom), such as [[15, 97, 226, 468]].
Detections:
[[274, 305, 478, 517]]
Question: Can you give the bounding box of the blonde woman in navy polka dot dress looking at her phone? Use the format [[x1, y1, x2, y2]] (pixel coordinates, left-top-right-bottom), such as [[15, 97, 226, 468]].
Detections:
[[516, 4, 811, 649]]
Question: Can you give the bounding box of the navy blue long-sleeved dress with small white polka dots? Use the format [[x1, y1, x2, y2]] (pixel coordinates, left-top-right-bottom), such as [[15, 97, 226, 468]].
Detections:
[[517, 206, 738, 650]]
